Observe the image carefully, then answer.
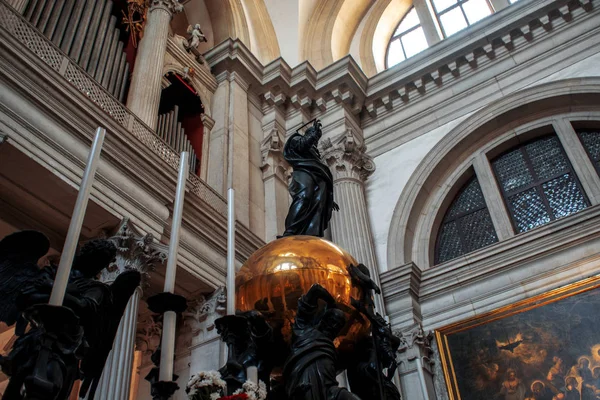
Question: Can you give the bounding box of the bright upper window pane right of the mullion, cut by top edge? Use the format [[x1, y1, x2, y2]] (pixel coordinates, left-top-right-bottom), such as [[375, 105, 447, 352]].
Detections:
[[433, 0, 494, 37]]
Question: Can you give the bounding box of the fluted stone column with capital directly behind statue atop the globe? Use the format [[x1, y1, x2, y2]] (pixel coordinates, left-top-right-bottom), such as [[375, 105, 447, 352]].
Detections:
[[322, 128, 386, 315]]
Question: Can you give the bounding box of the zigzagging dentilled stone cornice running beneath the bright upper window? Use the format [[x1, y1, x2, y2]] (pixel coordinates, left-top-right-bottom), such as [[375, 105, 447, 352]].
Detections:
[[205, 0, 597, 156]]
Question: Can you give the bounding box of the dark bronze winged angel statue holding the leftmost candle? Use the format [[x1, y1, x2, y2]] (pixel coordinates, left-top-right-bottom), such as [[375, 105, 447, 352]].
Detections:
[[0, 232, 141, 400]]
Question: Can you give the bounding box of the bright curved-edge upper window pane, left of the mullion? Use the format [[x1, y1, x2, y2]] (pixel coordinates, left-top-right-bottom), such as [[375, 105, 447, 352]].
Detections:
[[386, 7, 428, 68]]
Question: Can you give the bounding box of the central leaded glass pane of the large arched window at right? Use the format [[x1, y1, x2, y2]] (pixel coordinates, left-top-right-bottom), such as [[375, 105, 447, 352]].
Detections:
[[492, 135, 589, 233]]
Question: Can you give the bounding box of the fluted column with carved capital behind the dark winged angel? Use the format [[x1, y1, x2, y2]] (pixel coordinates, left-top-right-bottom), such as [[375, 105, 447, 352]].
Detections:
[[94, 218, 168, 400]]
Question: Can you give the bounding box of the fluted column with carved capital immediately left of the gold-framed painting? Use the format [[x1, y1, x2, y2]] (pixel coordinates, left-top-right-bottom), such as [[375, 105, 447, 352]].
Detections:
[[394, 325, 437, 400]]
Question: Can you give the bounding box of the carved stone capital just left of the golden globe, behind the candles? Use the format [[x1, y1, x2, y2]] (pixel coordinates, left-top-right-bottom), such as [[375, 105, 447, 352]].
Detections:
[[183, 287, 227, 339]]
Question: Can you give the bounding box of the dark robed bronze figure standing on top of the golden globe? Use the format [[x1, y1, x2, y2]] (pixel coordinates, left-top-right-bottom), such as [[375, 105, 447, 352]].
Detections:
[[283, 121, 335, 237]]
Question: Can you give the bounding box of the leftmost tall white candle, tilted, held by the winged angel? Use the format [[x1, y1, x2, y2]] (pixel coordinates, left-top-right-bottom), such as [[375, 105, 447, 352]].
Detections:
[[49, 128, 106, 306]]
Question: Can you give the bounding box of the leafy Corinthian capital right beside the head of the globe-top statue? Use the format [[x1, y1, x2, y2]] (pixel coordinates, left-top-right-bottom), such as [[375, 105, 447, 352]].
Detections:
[[322, 129, 375, 182]]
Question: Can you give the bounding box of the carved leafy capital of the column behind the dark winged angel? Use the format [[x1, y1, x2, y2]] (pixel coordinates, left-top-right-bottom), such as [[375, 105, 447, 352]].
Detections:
[[101, 218, 169, 285]]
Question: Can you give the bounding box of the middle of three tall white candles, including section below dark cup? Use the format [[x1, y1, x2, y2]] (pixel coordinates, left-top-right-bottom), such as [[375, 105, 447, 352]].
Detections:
[[159, 151, 189, 382]]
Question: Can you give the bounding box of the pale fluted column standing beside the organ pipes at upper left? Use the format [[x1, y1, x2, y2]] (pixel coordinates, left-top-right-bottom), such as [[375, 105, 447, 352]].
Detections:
[[127, 0, 183, 129]]
